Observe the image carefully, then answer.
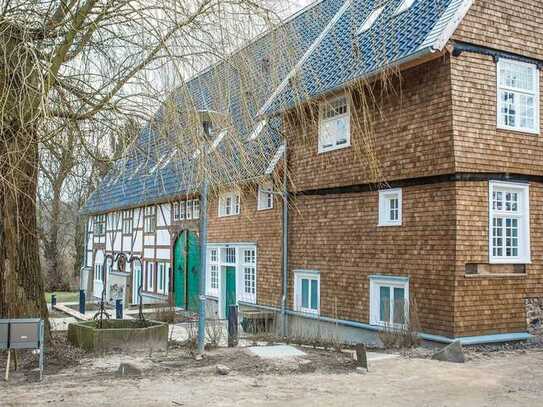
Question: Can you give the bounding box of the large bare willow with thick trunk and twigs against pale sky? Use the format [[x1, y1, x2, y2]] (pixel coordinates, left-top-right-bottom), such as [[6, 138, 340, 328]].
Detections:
[[0, 0, 280, 326]]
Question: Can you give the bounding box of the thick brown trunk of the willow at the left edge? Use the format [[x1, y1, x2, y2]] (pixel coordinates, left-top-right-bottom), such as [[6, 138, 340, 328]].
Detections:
[[0, 128, 49, 336]]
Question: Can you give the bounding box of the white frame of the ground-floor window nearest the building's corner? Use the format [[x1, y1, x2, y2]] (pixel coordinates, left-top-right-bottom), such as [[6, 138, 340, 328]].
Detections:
[[369, 275, 410, 328]]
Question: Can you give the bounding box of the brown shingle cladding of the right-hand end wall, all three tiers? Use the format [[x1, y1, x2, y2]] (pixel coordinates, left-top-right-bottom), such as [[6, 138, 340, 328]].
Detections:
[[451, 0, 543, 336]]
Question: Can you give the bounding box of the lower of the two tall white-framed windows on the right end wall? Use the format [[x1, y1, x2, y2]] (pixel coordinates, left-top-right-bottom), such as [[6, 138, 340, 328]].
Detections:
[[488, 181, 530, 264]]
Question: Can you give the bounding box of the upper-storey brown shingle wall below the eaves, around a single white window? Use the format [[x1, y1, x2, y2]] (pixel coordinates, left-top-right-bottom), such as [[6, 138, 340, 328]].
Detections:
[[286, 57, 454, 191]]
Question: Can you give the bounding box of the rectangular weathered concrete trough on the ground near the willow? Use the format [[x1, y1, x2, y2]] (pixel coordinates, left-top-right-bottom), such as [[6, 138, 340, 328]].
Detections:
[[68, 319, 168, 352]]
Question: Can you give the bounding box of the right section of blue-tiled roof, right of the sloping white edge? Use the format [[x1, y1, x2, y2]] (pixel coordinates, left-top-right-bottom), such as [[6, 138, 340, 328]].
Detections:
[[259, 0, 472, 115]]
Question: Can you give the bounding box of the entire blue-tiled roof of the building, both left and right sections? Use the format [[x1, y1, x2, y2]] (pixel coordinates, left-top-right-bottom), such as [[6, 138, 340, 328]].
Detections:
[[79, 0, 472, 214]]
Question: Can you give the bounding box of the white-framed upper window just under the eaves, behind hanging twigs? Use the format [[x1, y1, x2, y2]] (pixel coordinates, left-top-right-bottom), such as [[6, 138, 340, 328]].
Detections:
[[318, 95, 351, 153]]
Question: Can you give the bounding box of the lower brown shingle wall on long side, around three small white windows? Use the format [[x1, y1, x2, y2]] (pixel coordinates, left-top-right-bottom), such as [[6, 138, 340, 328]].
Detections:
[[289, 183, 455, 335]]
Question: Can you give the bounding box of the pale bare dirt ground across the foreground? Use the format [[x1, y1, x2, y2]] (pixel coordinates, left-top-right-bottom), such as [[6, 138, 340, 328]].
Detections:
[[0, 338, 543, 407]]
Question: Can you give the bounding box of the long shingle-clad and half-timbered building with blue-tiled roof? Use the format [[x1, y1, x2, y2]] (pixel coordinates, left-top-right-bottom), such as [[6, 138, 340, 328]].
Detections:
[[81, 0, 543, 343]]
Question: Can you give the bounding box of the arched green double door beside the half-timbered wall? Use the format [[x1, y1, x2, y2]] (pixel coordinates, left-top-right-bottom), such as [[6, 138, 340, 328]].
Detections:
[[173, 231, 200, 312]]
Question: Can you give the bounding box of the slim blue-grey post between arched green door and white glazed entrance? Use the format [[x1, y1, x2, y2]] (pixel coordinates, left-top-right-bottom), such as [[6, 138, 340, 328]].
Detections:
[[198, 180, 207, 355]]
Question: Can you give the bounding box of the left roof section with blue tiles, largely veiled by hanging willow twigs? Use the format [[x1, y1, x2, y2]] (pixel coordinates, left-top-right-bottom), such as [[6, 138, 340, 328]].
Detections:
[[82, 0, 342, 214]]
